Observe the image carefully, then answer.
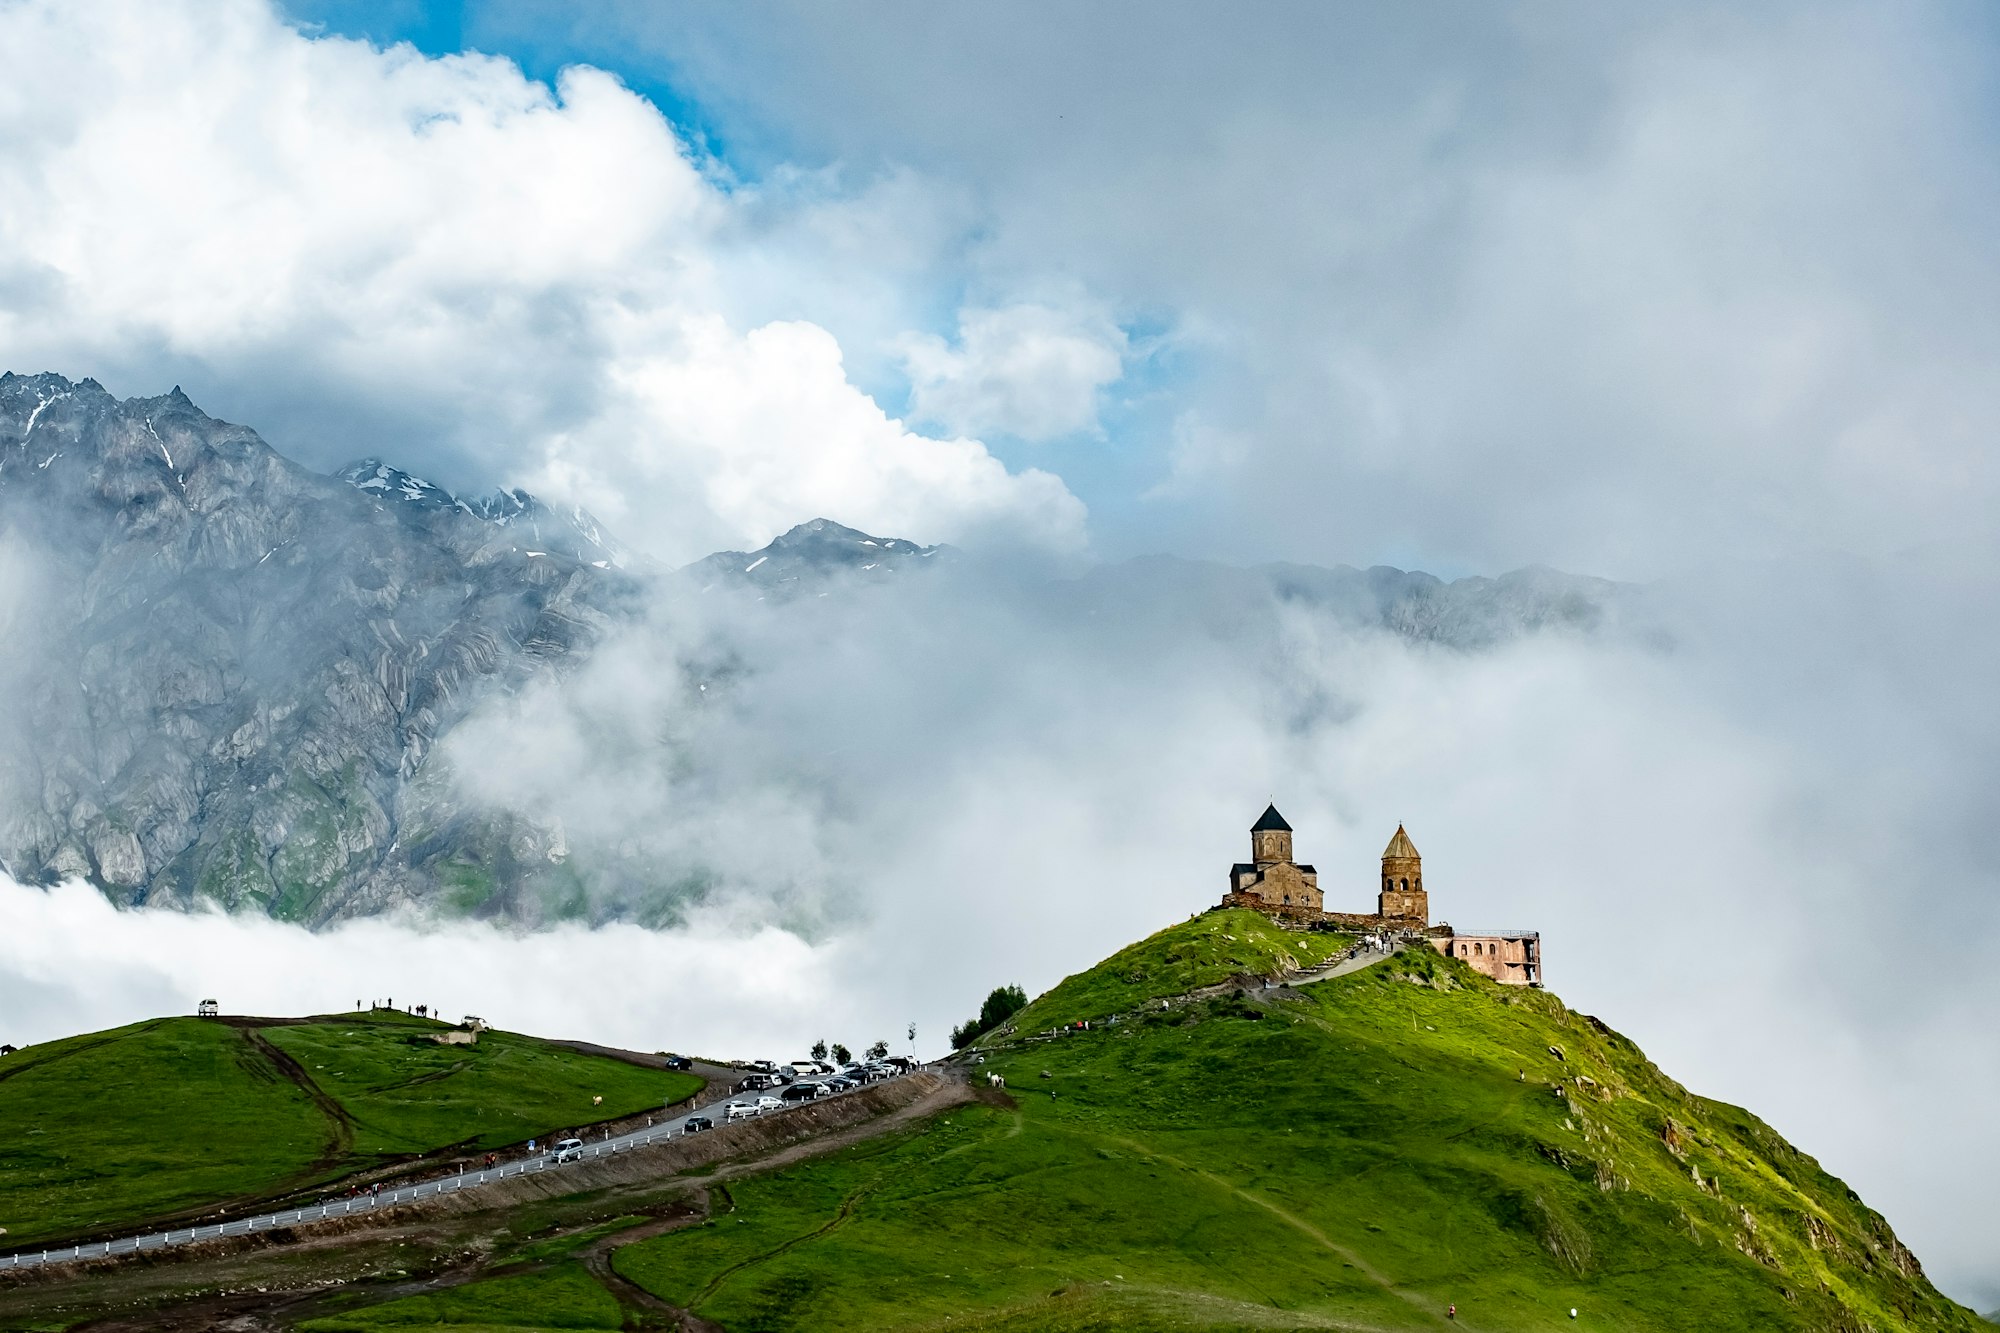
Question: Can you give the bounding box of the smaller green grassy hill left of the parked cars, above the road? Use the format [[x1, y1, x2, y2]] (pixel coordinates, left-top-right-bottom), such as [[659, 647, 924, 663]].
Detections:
[[0, 1011, 702, 1247]]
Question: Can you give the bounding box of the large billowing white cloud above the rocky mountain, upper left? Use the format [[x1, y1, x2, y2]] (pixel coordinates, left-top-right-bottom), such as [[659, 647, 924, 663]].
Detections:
[[0, 0, 1084, 558]]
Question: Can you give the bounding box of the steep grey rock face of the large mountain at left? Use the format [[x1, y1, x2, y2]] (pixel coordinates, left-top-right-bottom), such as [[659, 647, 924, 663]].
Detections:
[[0, 374, 628, 921]]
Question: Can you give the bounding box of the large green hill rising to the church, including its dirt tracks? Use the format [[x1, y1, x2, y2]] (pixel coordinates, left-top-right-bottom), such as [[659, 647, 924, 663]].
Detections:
[[0, 911, 1988, 1333]]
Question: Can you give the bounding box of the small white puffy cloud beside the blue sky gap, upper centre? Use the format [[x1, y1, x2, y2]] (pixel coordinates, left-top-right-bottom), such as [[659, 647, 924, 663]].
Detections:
[[902, 304, 1126, 440]]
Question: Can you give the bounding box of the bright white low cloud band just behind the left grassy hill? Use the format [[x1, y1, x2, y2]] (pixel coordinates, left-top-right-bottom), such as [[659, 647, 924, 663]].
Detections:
[[0, 877, 848, 1059]]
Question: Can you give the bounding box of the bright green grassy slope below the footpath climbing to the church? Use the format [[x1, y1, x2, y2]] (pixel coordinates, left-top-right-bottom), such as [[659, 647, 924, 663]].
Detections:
[[588, 919, 1982, 1333]]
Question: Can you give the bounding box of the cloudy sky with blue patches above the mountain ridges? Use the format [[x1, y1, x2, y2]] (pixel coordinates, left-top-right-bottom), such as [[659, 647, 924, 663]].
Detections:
[[6, 0, 2000, 578]]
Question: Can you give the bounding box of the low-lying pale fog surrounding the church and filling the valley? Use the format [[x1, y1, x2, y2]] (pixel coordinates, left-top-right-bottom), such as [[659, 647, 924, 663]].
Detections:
[[0, 556, 2000, 1303]]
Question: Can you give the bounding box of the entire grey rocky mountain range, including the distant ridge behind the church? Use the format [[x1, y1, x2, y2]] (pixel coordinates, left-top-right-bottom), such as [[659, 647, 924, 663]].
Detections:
[[0, 374, 1622, 925]]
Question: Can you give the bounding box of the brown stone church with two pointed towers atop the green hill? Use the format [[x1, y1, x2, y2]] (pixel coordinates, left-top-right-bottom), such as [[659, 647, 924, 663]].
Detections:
[[1222, 805, 1542, 987]]
